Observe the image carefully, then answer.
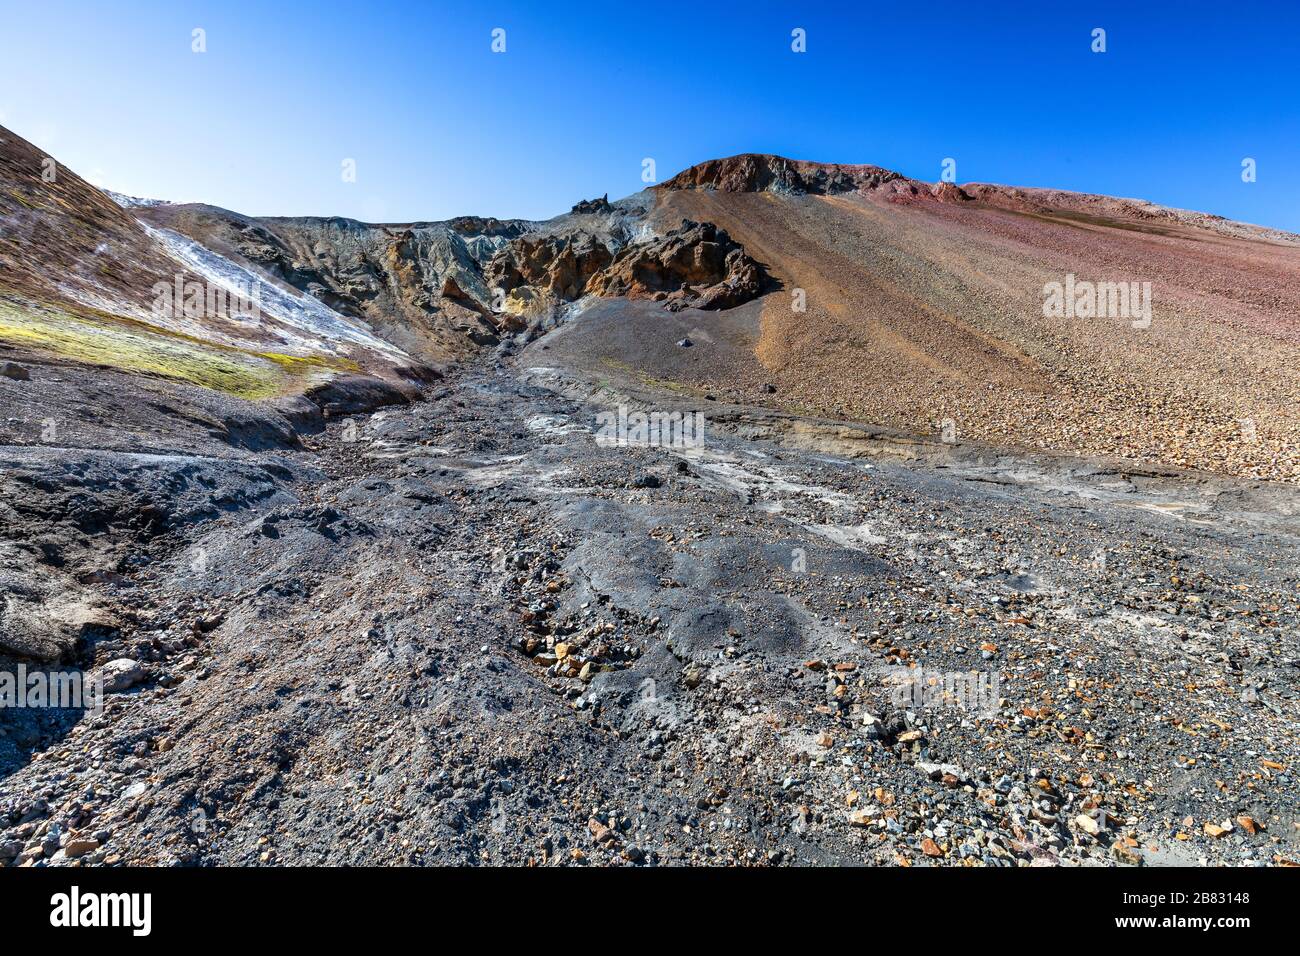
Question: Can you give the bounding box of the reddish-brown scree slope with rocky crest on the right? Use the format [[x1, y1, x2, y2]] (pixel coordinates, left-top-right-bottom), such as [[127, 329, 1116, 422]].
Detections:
[[655, 156, 1300, 480]]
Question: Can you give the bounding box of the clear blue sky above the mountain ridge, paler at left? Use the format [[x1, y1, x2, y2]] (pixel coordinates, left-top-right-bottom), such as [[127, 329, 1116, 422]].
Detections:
[[0, 0, 1300, 232]]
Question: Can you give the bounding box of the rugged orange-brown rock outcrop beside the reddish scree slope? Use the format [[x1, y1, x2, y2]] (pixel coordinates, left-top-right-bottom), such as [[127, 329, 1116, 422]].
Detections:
[[484, 221, 768, 311]]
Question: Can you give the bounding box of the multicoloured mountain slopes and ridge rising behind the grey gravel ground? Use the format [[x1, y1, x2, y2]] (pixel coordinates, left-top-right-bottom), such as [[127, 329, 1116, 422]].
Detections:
[[0, 131, 1300, 480]]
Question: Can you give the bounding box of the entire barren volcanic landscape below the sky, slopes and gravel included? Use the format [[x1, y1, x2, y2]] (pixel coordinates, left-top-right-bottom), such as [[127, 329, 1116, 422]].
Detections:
[[0, 123, 1300, 868]]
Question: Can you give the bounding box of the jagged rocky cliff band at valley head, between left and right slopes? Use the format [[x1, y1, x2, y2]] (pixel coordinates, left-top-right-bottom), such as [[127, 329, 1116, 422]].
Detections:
[[135, 187, 767, 359]]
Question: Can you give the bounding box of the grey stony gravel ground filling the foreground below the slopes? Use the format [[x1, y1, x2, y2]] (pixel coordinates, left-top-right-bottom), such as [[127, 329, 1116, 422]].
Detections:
[[0, 338, 1300, 866]]
